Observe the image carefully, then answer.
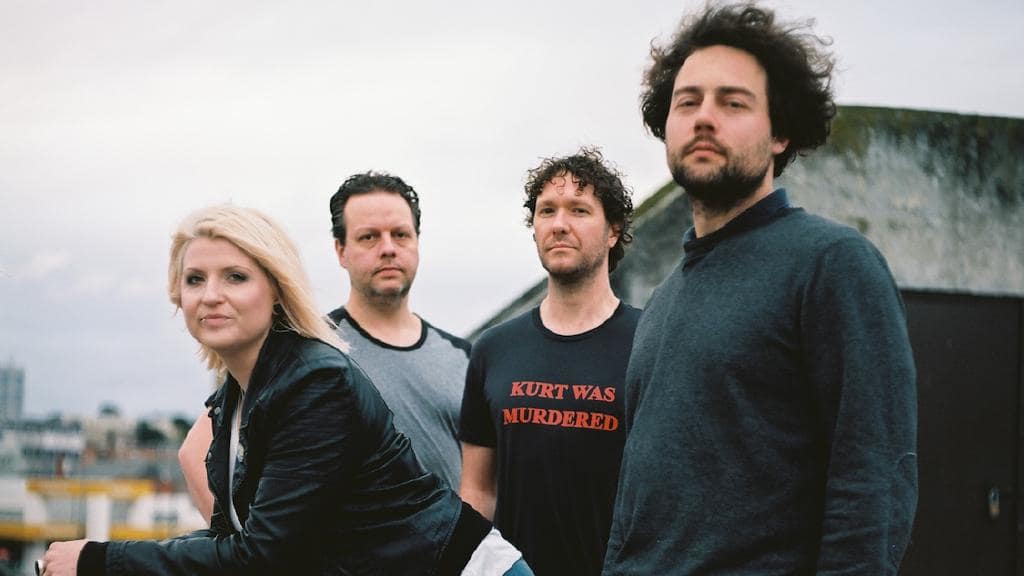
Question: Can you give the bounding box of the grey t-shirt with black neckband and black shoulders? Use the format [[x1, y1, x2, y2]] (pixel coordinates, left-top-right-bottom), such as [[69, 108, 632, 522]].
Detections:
[[328, 307, 470, 483]]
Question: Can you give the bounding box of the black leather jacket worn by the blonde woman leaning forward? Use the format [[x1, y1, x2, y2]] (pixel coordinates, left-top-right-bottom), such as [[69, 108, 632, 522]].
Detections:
[[79, 327, 490, 576]]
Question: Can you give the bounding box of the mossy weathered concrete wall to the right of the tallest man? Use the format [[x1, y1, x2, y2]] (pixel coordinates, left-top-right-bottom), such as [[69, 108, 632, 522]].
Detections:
[[778, 107, 1024, 295]]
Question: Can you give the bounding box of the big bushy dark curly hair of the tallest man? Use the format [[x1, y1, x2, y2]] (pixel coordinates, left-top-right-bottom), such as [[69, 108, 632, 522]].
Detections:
[[640, 3, 836, 176]]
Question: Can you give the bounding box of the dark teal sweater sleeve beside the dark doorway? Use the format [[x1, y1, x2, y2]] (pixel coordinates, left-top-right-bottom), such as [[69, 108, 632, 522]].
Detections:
[[802, 237, 918, 575]]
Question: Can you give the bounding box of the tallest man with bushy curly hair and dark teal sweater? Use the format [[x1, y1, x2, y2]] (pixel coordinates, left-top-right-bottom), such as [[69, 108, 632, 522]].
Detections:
[[604, 4, 916, 575]]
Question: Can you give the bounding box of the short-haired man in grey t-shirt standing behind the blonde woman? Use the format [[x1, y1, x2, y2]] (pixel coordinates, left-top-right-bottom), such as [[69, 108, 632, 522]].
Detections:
[[330, 172, 469, 488]]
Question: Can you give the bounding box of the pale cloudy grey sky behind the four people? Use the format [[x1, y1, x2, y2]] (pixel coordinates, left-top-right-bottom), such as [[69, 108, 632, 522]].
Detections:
[[0, 0, 1024, 415]]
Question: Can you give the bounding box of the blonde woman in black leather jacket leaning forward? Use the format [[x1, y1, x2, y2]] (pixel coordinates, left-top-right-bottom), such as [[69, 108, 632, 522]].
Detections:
[[39, 206, 532, 576]]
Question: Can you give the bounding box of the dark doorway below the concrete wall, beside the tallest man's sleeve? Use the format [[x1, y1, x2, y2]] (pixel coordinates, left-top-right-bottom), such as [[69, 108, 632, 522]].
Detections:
[[901, 291, 1024, 576]]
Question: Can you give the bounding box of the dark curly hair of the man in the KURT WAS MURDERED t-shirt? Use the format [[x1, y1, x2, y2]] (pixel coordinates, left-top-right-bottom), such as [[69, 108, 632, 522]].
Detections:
[[522, 148, 633, 273]]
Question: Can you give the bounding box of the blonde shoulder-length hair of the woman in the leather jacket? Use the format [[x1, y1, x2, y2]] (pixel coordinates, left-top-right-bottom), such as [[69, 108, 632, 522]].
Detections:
[[167, 204, 348, 372]]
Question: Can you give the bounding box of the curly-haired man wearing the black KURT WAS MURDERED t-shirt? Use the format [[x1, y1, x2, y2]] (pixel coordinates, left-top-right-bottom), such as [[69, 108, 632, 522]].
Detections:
[[460, 149, 640, 576]]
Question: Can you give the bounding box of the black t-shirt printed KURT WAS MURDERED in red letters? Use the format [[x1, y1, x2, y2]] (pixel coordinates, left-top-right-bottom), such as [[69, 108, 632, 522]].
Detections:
[[460, 303, 640, 576]]
